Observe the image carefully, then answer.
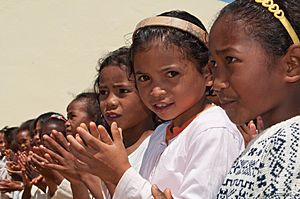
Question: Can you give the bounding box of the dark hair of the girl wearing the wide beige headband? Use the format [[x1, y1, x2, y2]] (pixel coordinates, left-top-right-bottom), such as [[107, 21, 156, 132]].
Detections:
[[130, 10, 209, 73]]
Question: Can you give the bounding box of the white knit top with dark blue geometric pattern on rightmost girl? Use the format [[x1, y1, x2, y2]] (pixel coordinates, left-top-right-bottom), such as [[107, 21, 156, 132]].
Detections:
[[218, 116, 300, 199]]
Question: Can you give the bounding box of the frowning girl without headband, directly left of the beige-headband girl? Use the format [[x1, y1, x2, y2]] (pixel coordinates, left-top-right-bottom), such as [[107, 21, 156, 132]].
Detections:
[[39, 47, 154, 198]]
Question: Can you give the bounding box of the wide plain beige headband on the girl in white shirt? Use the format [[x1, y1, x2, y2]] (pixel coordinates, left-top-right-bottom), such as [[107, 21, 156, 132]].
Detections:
[[134, 16, 208, 47]]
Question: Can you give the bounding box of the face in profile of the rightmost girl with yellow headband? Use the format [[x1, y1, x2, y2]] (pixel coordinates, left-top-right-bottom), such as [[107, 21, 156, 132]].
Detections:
[[209, 16, 286, 124]]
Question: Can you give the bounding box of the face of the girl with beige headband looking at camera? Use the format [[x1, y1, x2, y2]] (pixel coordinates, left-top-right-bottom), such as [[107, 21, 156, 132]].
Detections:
[[134, 41, 212, 126]]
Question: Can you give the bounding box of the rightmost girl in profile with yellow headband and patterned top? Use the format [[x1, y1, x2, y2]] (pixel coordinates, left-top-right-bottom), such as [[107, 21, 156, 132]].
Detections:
[[209, 0, 300, 198]]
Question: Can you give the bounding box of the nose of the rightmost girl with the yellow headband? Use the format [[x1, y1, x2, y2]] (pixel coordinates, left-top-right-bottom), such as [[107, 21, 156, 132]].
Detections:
[[212, 66, 229, 93]]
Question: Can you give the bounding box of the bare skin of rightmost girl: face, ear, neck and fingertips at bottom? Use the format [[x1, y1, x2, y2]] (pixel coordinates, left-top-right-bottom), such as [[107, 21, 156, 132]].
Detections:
[[152, 15, 300, 199]]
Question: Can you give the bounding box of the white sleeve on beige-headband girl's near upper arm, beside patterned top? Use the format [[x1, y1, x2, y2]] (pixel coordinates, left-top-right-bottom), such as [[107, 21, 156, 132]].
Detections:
[[173, 128, 244, 199]]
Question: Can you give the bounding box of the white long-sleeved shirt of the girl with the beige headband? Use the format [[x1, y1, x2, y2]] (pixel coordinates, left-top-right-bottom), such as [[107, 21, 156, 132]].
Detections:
[[114, 106, 244, 199]]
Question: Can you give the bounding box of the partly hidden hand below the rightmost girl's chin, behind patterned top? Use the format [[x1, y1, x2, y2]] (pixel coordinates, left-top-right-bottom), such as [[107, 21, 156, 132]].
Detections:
[[237, 116, 264, 146]]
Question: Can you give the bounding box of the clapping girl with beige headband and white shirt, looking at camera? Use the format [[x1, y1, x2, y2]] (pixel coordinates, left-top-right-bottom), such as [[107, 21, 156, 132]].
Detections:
[[68, 11, 243, 198]]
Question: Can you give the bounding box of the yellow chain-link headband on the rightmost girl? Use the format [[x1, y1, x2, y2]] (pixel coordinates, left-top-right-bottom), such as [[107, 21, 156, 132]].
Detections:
[[255, 0, 300, 44]]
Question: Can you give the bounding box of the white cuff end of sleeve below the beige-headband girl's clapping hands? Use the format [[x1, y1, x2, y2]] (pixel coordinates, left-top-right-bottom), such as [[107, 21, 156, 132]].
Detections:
[[113, 167, 152, 199]]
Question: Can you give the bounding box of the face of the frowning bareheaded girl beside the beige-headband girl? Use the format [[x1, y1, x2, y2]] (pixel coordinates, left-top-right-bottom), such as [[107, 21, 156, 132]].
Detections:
[[99, 65, 151, 130]]
